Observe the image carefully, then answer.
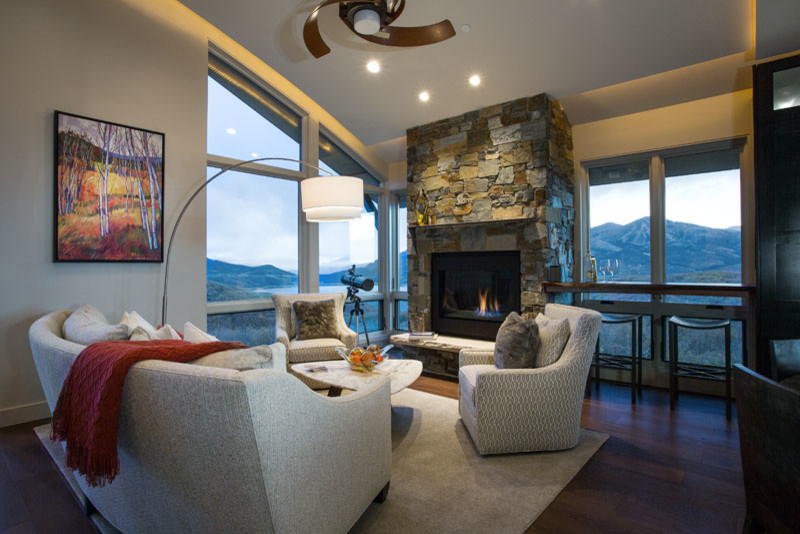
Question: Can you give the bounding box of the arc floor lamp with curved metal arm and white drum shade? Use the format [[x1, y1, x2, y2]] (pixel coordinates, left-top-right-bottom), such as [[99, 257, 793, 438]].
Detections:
[[161, 157, 364, 324]]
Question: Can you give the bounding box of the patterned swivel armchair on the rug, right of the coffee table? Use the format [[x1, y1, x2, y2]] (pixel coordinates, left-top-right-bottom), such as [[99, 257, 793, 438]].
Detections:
[[458, 304, 601, 454]]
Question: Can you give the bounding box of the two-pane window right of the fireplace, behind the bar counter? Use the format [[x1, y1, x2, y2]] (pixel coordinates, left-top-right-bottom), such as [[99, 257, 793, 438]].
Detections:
[[584, 141, 743, 372]]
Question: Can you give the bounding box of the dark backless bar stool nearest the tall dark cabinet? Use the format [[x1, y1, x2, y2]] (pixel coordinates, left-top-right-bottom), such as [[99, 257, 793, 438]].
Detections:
[[669, 316, 731, 419]]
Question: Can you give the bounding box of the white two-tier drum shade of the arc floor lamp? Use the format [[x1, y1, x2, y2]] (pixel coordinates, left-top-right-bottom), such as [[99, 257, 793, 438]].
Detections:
[[300, 176, 364, 222]]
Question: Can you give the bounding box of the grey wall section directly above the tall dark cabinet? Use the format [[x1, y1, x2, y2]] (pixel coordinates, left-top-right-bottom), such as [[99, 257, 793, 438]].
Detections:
[[756, 0, 800, 59]]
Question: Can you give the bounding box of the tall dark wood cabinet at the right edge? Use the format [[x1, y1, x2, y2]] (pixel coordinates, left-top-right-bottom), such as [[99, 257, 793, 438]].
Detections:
[[753, 55, 800, 376]]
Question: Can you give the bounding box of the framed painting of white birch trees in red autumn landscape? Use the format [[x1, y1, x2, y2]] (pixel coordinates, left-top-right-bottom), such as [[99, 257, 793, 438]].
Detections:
[[54, 111, 164, 262]]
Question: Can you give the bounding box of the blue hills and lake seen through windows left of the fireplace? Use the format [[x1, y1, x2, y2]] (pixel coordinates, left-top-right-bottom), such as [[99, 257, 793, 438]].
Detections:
[[206, 252, 408, 302]]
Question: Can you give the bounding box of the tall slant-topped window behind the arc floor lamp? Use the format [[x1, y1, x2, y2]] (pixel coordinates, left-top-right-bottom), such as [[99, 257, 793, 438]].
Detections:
[[207, 55, 388, 345]]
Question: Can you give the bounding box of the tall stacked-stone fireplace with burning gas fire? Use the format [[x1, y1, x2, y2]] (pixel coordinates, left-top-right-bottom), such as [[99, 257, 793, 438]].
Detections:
[[407, 94, 575, 339]]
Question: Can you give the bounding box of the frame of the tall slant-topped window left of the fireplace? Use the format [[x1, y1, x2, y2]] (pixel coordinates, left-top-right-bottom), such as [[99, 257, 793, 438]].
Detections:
[[206, 48, 396, 342]]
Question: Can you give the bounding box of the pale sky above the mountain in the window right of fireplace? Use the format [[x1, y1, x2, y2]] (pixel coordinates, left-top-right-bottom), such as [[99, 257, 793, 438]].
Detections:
[[589, 169, 741, 228]]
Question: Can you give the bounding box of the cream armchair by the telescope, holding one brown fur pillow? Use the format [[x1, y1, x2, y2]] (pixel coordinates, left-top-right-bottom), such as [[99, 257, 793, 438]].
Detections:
[[272, 293, 358, 389]]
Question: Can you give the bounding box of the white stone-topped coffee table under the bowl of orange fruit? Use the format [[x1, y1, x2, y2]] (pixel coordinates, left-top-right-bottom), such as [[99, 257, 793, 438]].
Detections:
[[292, 359, 422, 397]]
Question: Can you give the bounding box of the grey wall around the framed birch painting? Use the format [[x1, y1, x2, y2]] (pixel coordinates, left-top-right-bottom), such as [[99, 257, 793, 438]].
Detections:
[[0, 0, 208, 426]]
